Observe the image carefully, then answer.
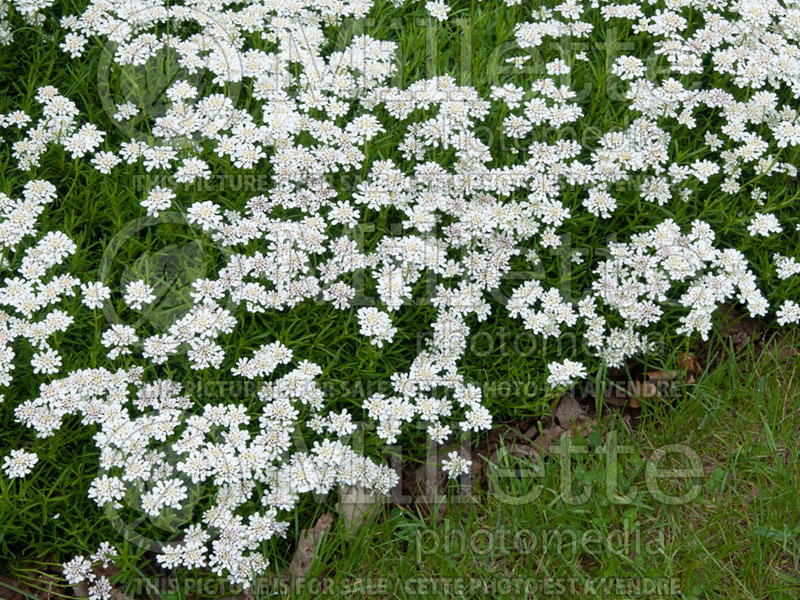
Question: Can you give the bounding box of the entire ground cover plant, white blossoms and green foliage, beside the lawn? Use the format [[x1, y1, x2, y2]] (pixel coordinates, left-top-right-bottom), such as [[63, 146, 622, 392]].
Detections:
[[0, 0, 800, 598]]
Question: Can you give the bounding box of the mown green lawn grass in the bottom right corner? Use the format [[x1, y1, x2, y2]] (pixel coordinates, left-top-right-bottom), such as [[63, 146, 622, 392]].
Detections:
[[233, 338, 800, 599]]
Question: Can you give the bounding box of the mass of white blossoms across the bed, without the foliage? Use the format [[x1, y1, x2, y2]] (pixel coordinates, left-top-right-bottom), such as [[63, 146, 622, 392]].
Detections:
[[0, 0, 800, 584]]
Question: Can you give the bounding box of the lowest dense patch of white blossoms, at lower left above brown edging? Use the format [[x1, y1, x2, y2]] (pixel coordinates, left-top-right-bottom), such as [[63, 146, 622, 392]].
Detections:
[[17, 360, 398, 584]]
